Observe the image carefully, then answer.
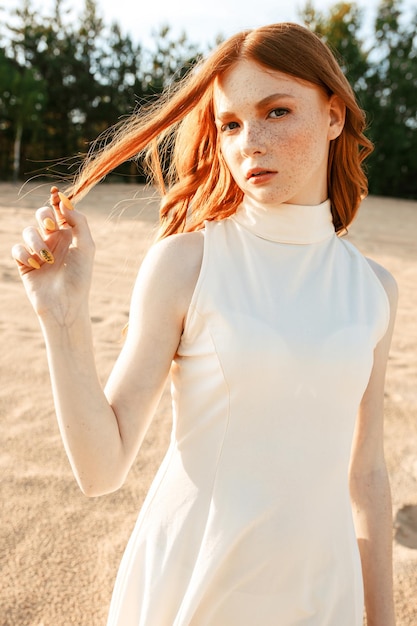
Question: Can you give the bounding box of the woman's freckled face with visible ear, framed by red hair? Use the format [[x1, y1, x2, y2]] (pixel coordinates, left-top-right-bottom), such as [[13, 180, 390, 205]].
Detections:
[[214, 60, 344, 206]]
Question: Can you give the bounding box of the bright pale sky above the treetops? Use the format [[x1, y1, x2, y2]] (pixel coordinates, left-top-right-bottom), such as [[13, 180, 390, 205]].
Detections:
[[0, 0, 416, 49]]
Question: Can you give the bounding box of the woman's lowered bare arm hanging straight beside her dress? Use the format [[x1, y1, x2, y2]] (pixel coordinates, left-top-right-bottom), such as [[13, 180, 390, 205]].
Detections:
[[350, 264, 397, 626]]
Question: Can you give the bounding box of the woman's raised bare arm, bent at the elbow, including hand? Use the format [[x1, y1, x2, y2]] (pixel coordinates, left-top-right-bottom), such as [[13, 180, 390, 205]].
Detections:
[[13, 193, 202, 496]]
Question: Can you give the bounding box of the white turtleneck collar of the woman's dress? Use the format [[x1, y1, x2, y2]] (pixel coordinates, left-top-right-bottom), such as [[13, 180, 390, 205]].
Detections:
[[232, 196, 335, 244]]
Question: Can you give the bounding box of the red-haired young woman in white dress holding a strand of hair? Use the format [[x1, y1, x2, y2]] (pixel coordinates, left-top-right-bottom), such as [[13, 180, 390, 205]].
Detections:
[[13, 24, 396, 626]]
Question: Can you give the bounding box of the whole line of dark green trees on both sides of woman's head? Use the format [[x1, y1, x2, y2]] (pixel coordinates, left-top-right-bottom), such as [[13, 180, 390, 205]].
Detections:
[[0, 0, 417, 198]]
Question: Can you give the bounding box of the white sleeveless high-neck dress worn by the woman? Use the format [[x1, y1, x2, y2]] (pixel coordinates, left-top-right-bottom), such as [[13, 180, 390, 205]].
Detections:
[[108, 199, 389, 626]]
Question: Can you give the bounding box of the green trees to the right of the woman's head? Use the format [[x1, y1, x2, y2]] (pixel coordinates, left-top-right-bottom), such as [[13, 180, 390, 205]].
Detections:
[[301, 0, 417, 198]]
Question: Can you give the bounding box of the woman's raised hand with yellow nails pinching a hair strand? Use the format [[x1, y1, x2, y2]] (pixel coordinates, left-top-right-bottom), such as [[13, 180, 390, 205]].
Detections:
[[12, 187, 94, 326]]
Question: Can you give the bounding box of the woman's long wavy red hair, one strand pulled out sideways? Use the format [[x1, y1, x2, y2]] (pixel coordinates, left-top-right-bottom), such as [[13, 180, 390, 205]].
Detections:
[[69, 23, 372, 238]]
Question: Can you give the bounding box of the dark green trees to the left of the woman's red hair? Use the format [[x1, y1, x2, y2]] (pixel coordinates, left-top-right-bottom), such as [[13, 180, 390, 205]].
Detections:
[[0, 0, 202, 180]]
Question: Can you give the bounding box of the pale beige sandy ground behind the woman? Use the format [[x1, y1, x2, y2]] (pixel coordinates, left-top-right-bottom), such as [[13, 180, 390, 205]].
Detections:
[[0, 184, 417, 626]]
